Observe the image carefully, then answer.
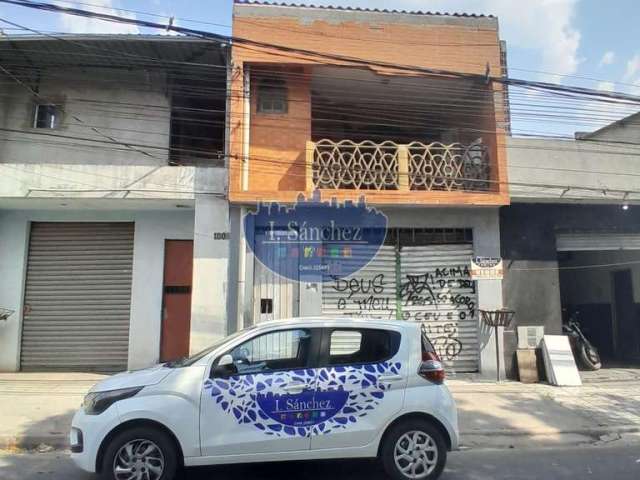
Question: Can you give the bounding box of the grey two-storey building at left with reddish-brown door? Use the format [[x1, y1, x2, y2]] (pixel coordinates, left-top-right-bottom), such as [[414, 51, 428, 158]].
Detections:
[[0, 35, 229, 371]]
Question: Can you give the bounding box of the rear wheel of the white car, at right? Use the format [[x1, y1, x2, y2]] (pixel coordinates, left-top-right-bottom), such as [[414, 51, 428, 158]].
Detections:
[[380, 419, 447, 480]]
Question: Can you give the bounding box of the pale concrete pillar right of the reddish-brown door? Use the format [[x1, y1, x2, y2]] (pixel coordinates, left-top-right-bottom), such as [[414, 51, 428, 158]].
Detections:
[[190, 194, 230, 353]]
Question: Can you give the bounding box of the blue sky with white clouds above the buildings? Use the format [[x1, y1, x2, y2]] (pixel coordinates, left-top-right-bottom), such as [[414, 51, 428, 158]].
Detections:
[[0, 0, 640, 133]]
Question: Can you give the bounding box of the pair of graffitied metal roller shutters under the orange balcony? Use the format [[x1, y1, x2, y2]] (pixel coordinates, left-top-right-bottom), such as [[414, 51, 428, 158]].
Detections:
[[322, 243, 479, 372]]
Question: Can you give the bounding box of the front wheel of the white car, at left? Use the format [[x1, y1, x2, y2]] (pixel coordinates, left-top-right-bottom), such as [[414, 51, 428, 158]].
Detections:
[[101, 427, 178, 480]]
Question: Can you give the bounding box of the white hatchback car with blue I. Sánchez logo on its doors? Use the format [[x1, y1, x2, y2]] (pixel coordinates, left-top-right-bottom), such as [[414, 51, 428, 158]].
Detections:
[[70, 318, 458, 480]]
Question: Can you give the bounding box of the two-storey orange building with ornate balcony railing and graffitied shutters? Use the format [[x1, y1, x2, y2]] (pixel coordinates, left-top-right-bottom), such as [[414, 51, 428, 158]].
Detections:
[[229, 1, 509, 376]]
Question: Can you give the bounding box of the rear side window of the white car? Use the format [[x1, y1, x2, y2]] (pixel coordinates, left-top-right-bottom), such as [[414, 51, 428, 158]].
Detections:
[[326, 328, 400, 365]]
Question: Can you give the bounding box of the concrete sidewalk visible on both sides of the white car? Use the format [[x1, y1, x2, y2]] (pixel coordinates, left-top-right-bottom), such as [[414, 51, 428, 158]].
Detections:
[[0, 373, 640, 449]]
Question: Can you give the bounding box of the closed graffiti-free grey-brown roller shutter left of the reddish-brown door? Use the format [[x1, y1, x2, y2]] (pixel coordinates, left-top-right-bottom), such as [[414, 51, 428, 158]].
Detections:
[[21, 223, 134, 371]]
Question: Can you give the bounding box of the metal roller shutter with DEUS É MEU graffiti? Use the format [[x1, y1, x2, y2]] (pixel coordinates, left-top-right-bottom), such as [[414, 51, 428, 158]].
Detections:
[[322, 245, 396, 320]]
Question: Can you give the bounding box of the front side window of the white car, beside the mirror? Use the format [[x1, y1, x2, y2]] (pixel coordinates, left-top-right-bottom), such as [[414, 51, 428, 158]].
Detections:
[[229, 328, 311, 375]]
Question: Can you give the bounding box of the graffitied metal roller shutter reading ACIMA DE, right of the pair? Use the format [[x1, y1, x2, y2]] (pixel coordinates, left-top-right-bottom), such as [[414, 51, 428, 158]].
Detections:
[[400, 244, 479, 372]]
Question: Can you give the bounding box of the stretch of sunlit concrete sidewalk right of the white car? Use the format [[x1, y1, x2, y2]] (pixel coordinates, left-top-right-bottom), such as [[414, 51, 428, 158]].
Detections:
[[448, 380, 640, 448]]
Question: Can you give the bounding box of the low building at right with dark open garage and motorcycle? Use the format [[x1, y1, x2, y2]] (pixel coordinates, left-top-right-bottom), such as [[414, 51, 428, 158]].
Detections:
[[500, 114, 640, 376]]
